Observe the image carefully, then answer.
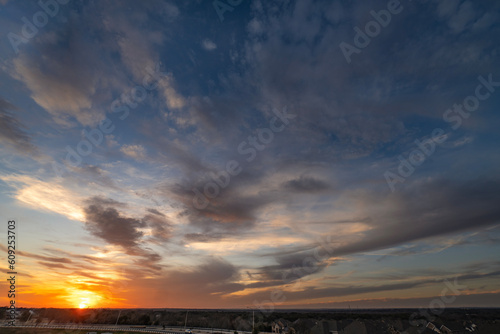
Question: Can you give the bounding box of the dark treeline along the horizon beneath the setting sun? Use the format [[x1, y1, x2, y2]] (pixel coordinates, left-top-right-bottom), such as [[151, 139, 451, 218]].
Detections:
[[0, 307, 500, 334]]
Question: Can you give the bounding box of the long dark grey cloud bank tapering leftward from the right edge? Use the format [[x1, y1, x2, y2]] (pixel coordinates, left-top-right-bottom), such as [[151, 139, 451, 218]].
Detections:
[[326, 178, 500, 256]]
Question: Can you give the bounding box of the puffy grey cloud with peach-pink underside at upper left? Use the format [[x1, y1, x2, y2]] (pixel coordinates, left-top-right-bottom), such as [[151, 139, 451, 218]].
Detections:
[[14, 43, 100, 126]]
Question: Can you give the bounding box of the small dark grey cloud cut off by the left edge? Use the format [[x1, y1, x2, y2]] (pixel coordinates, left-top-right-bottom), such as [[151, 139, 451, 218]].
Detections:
[[0, 98, 37, 155]]
